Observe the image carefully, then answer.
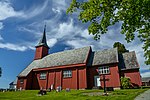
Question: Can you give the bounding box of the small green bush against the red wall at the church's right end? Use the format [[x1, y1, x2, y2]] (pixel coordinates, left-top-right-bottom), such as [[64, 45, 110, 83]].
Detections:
[[121, 77, 131, 89]]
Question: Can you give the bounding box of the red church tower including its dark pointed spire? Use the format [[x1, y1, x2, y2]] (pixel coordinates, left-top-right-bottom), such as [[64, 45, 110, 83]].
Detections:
[[34, 25, 49, 60]]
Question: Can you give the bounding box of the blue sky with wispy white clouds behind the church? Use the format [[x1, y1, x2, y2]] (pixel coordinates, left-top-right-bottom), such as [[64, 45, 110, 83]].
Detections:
[[0, 0, 150, 88]]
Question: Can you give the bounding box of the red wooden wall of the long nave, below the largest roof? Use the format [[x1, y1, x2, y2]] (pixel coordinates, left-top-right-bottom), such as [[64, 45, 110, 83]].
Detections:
[[17, 66, 87, 89]]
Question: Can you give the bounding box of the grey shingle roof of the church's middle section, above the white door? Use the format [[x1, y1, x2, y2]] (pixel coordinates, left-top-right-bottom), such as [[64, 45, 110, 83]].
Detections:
[[92, 48, 118, 66]]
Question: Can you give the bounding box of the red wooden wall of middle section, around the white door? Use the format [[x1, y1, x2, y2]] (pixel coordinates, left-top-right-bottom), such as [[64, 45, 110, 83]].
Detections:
[[87, 64, 120, 88]]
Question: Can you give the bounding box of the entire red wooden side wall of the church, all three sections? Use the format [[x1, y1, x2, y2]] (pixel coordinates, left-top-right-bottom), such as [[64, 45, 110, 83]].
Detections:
[[17, 64, 142, 89]]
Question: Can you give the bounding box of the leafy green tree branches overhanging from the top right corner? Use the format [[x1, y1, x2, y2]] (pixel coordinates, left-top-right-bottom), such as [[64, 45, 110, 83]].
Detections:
[[67, 0, 150, 65]]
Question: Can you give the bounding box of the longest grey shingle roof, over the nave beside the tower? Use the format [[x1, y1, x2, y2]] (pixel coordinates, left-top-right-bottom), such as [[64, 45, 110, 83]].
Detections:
[[19, 47, 90, 76]]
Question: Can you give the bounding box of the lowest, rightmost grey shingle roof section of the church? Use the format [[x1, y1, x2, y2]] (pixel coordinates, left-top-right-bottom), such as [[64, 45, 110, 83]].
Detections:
[[119, 51, 139, 70]]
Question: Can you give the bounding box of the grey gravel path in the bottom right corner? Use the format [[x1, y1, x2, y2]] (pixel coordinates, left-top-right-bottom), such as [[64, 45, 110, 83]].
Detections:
[[134, 89, 150, 100]]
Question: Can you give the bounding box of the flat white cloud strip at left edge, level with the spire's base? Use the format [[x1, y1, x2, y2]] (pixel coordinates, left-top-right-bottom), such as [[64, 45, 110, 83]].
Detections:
[[0, 43, 28, 51]]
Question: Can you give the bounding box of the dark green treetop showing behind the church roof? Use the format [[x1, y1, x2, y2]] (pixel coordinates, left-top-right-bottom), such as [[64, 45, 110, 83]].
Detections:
[[113, 42, 129, 54]]
